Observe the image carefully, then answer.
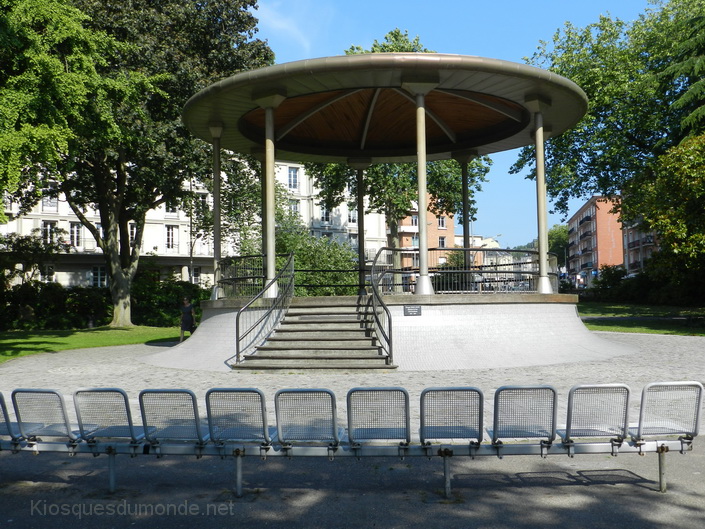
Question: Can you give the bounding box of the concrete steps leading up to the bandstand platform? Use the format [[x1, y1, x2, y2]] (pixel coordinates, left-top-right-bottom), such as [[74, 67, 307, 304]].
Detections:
[[233, 296, 396, 370]]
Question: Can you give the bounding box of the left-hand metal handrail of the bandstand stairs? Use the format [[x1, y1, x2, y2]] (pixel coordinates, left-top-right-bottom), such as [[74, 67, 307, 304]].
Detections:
[[225, 254, 294, 366]]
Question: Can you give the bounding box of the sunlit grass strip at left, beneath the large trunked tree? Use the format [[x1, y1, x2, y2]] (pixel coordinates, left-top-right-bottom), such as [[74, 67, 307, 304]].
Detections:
[[0, 326, 179, 363]]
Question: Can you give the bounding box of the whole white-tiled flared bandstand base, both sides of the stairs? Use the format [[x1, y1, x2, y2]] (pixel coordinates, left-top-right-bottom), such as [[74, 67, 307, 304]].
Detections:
[[142, 294, 634, 371]]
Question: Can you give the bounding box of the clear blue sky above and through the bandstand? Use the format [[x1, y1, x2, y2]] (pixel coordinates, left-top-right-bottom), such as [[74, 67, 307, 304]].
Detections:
[[256, 0, 651, 247]]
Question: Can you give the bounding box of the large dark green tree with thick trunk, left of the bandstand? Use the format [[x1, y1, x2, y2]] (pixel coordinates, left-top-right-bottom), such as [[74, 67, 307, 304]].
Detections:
[[3, 0, 272, 326]]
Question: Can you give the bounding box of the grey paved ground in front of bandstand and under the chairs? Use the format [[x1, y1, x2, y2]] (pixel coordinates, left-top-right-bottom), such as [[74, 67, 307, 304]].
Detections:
[[0, 333, 705, 529]]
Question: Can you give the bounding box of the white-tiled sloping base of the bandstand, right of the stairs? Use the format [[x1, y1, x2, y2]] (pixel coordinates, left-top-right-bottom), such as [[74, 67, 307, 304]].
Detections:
[[390, 303, 637, 371]]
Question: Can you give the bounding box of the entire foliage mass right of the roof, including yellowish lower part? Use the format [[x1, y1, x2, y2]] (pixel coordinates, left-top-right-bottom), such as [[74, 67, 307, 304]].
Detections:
[[512, 0, 705, 269]]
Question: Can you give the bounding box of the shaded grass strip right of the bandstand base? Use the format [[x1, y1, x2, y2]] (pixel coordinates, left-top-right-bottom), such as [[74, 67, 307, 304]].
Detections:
[[578, 302, 705, 336]]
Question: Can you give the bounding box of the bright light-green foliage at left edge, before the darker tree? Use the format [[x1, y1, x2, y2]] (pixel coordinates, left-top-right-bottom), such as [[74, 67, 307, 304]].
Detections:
[[0, 0, 144, 218]]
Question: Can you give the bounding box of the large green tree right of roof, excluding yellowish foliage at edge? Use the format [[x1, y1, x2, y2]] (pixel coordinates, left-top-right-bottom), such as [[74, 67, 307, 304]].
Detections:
[[512, 0, 705, 213]]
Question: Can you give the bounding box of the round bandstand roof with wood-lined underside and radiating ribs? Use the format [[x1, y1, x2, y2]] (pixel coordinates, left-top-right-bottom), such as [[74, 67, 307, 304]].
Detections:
[[183, 53, 587, 163]]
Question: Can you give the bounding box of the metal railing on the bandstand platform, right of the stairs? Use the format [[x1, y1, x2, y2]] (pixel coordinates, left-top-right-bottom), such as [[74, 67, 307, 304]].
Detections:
[[373, 248, 558, 295]]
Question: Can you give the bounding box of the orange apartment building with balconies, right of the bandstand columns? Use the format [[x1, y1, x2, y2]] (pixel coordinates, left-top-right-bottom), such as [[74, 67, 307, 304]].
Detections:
[[568, 195, 624, 288]]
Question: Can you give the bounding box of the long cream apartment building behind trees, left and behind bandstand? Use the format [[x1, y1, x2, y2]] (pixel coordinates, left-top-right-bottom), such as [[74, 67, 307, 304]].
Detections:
[[0, 162, 387, 287]]
